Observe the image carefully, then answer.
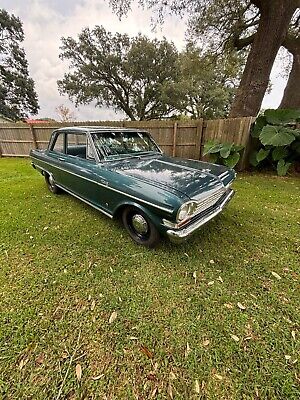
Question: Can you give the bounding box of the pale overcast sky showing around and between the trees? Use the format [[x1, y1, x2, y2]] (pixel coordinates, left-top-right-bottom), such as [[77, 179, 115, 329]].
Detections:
[[0, 0, 285, 121]]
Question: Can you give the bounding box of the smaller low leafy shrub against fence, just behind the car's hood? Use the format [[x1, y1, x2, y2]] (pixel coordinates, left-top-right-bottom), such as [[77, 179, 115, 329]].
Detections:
[[203, 141, 245, 168]]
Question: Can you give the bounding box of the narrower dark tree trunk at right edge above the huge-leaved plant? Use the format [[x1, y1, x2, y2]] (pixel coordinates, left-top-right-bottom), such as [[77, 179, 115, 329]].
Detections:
[[278, 37, 300, 110]]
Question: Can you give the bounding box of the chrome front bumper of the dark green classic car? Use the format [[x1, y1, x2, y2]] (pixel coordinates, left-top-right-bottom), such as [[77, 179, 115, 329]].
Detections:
[[167, 189, 234, 243]]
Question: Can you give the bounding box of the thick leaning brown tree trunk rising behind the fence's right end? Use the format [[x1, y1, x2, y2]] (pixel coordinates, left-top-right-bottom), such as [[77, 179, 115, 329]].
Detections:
[[230, 0, 298, 117]]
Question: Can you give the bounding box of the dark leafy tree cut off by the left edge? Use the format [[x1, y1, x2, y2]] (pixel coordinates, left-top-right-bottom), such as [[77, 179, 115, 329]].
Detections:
[[0, 9, 39, 120]]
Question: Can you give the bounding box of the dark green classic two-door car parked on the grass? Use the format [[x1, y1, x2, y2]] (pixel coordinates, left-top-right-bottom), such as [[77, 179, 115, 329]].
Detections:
[[30, 126, 236, 247]]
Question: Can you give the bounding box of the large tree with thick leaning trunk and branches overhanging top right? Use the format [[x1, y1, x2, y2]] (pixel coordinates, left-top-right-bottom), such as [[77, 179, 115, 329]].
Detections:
[[111, 0, 300, 117]]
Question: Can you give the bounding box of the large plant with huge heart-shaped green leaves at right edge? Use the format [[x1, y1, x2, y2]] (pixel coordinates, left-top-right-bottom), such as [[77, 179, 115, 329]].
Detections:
[[250, 109, 300, 176]]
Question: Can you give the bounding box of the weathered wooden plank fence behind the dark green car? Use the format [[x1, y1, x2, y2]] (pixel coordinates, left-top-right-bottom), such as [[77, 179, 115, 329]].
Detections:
[[0, 117, 255, 169]]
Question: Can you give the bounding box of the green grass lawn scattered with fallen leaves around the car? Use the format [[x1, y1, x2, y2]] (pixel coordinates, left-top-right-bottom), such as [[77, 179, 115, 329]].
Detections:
[[0, 159, 300, 400]]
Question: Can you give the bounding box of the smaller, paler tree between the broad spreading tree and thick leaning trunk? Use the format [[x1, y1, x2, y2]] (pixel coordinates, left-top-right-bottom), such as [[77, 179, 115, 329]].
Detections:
[[176, 44, 242, 119]]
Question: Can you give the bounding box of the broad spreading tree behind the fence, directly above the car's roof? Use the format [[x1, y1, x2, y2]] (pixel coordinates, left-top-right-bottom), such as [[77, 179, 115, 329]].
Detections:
[[58, 26, 179, 120]]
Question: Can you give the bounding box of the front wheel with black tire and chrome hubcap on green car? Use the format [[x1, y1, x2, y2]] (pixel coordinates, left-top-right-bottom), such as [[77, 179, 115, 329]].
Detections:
[[122, 207, 160, 248]]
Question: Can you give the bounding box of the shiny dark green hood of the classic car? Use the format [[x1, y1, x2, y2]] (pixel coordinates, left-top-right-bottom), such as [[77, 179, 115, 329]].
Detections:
[[111, 156, 235, 198]]
